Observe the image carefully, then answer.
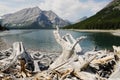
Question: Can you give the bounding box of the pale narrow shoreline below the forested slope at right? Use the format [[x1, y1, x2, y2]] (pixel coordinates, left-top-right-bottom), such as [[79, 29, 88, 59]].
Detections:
[[66, 29, 120, 36]]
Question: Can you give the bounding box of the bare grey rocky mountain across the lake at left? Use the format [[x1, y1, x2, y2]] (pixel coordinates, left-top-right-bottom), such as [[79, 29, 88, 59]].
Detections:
[[1, 7, 69, 29]]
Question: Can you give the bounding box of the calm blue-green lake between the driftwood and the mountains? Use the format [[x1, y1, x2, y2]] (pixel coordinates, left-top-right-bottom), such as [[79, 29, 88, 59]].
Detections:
[[0, 30, 120, 52]]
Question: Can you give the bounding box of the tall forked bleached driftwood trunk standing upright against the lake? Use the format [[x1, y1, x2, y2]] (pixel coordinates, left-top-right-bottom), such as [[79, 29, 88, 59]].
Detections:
[[50, 28, 86, 69]]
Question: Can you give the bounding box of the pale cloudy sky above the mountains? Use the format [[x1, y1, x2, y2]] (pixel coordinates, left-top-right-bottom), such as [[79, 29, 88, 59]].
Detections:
[[0, 0, 112, 21]]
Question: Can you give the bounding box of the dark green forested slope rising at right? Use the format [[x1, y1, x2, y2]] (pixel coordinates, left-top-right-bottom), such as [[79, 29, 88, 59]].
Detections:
[[65, 0, 120, 29]]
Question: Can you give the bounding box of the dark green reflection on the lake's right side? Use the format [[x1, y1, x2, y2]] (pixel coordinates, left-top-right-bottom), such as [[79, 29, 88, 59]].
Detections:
[[91, 33, 120, 49]]
